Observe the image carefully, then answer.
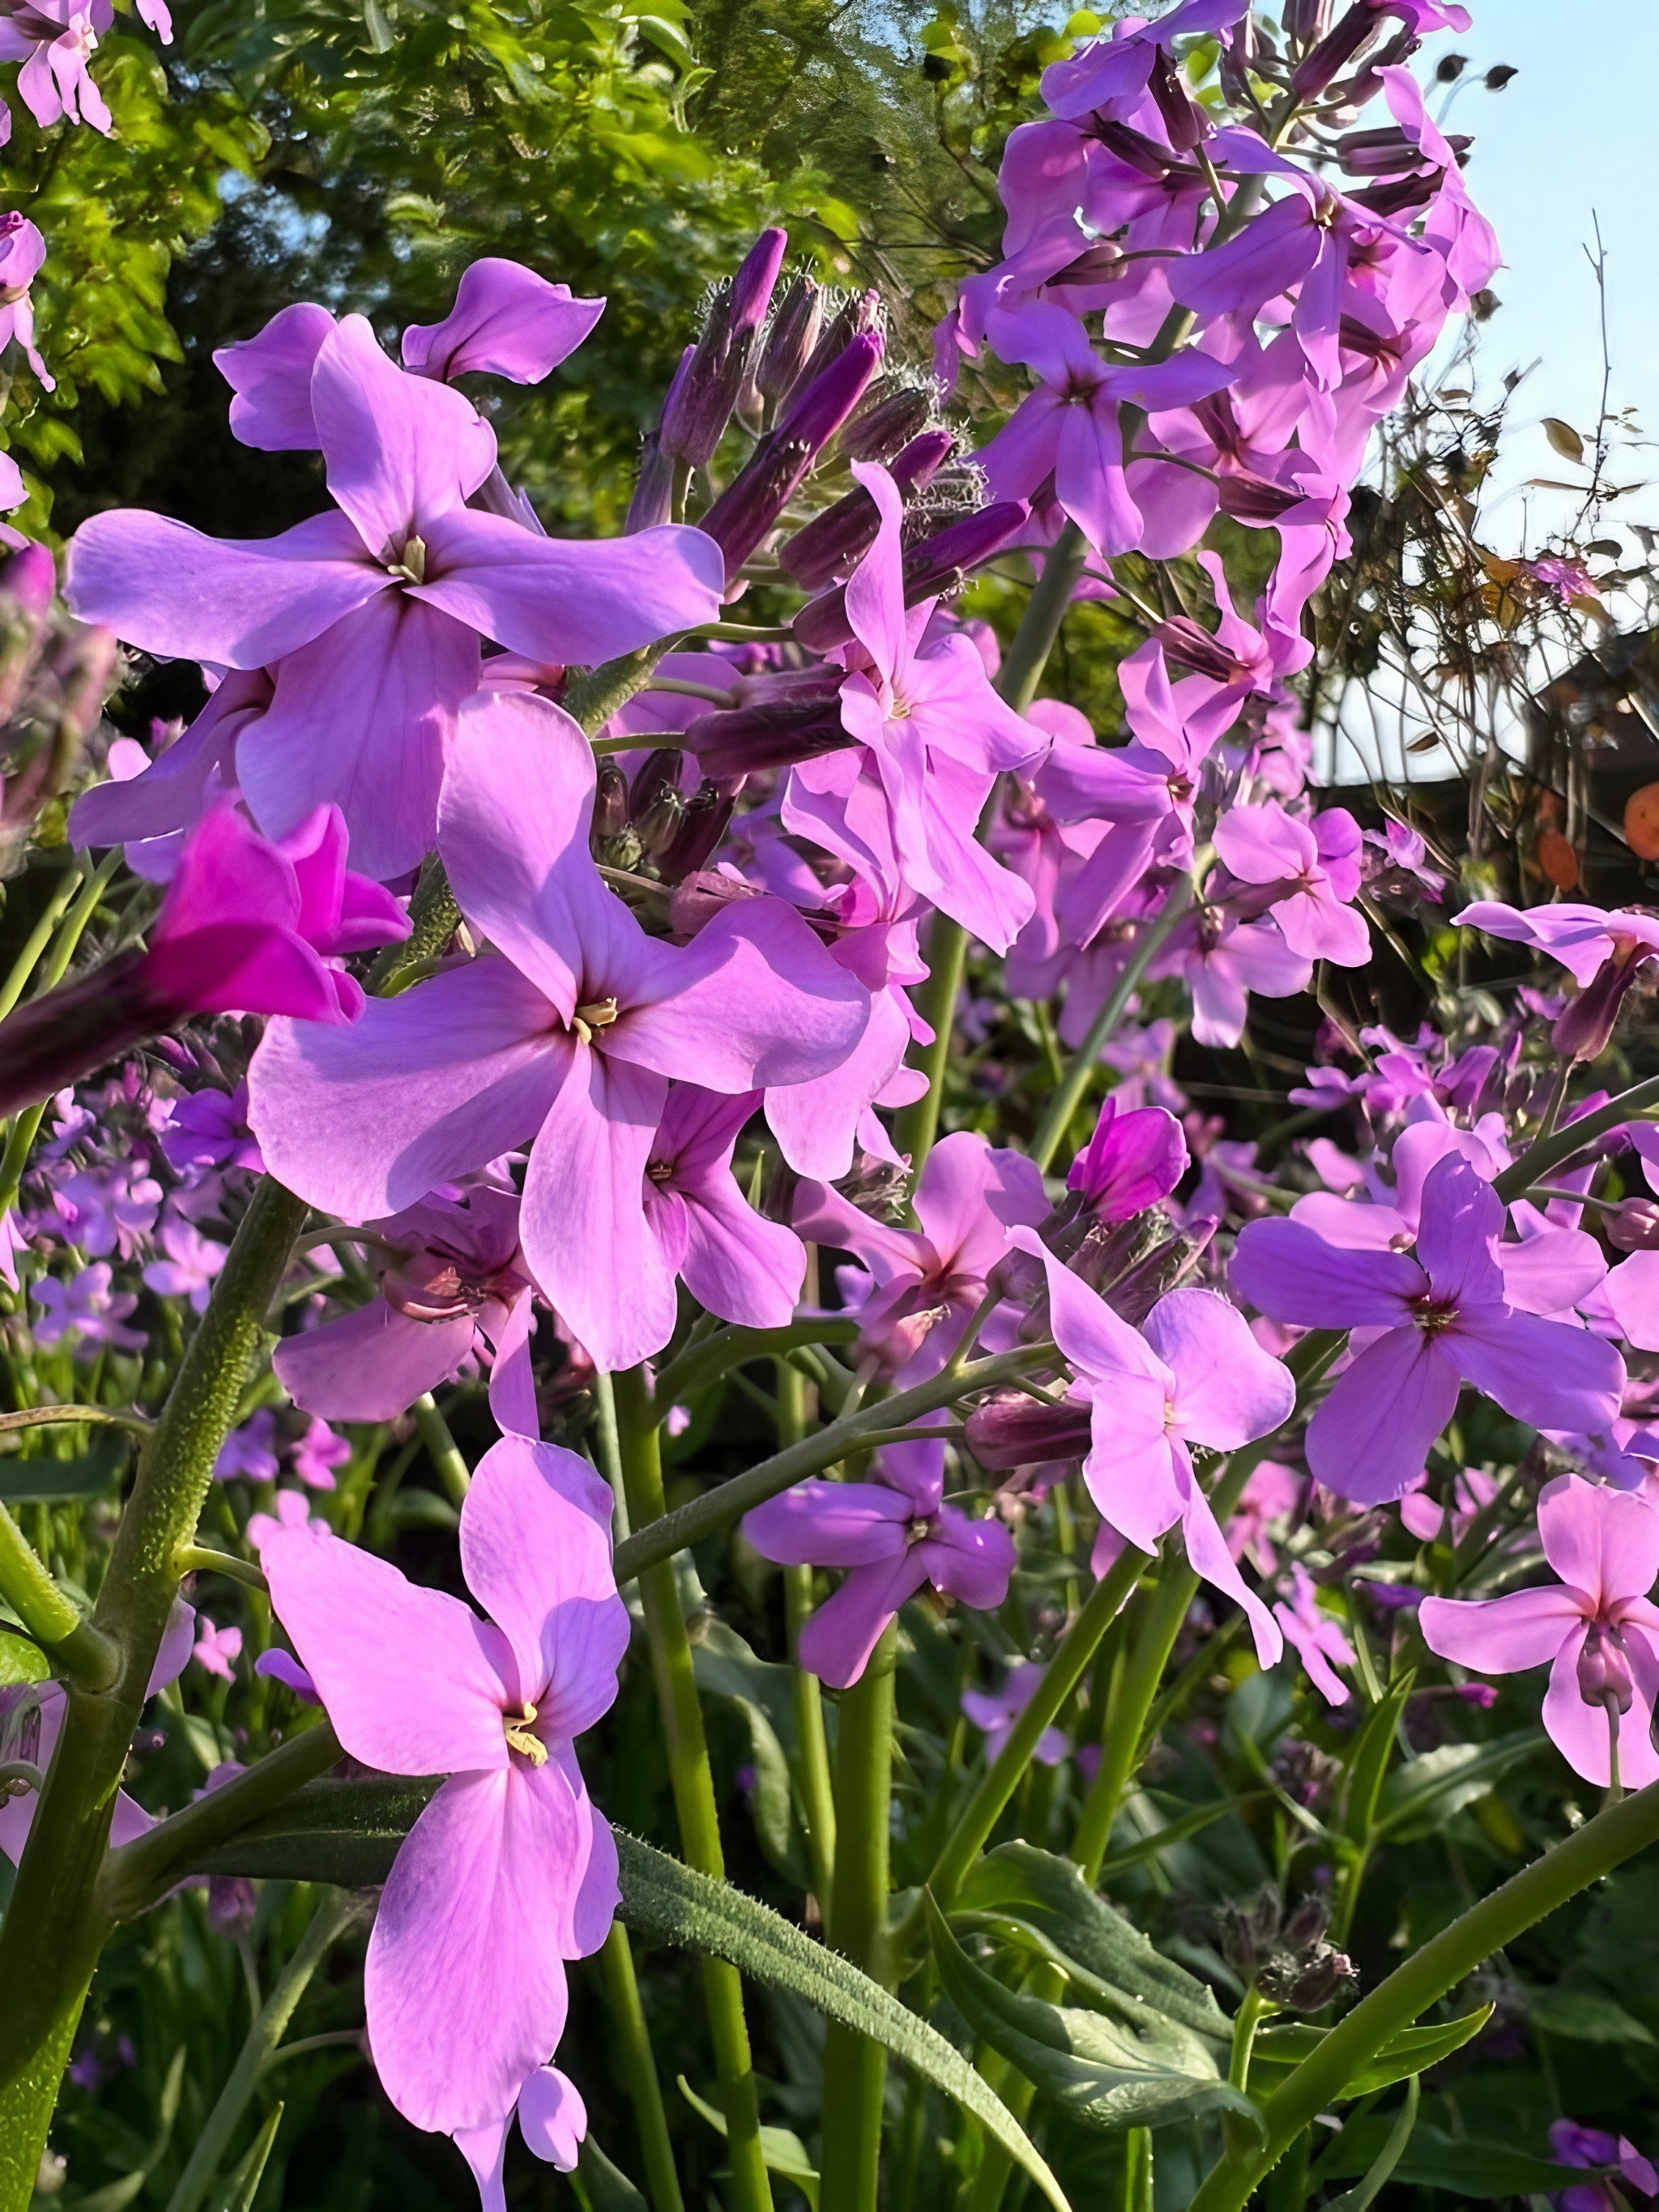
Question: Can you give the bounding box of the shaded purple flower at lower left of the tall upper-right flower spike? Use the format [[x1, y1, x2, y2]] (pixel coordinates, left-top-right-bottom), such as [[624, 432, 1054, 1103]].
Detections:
[[978, 299, 1232, 555]]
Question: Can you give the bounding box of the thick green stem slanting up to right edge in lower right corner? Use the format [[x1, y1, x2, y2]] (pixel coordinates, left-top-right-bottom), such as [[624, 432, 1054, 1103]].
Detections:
[[1192, 1783, 1659, 2212]]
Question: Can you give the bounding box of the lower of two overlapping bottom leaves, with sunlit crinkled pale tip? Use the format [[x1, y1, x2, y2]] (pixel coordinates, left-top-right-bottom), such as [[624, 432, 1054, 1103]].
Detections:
[[924, 1894, 1265, 2137]]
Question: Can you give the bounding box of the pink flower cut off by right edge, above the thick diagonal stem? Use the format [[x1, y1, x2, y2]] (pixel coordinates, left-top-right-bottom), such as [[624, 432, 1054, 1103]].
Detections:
[[1418, 1476, 1659, 1789]]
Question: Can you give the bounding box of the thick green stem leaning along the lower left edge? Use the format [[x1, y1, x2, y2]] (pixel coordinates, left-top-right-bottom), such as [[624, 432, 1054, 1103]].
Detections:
[[0, 1177, 305, 2096]]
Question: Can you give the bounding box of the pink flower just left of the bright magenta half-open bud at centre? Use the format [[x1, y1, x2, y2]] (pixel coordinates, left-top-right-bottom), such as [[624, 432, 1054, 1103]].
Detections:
[[792, 1131, 1048, 1389]]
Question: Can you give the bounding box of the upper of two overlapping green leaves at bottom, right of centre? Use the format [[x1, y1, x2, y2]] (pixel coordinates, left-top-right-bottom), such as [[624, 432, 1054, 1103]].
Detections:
[[951, 1843, 1232, 2044]]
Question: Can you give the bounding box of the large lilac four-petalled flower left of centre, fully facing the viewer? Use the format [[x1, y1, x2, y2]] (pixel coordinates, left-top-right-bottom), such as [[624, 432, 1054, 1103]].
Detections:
[[250, 693, 869, 1367]]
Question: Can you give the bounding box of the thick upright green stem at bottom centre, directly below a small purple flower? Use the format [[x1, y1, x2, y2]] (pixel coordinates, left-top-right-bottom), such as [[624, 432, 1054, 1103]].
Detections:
[[821, 1622, 898, 2212]]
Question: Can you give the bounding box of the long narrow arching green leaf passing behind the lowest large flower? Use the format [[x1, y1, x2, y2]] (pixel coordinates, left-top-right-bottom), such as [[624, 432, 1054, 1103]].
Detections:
[[191, 1776, 1071, 2212]]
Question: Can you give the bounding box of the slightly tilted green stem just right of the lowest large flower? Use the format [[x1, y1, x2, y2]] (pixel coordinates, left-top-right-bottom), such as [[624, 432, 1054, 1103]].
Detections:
[[612, 1367, 772, 2212]]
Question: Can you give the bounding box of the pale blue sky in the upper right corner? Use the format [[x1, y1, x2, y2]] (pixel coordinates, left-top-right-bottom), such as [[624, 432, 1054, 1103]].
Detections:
[[1425, 0, 1659, 539]]
